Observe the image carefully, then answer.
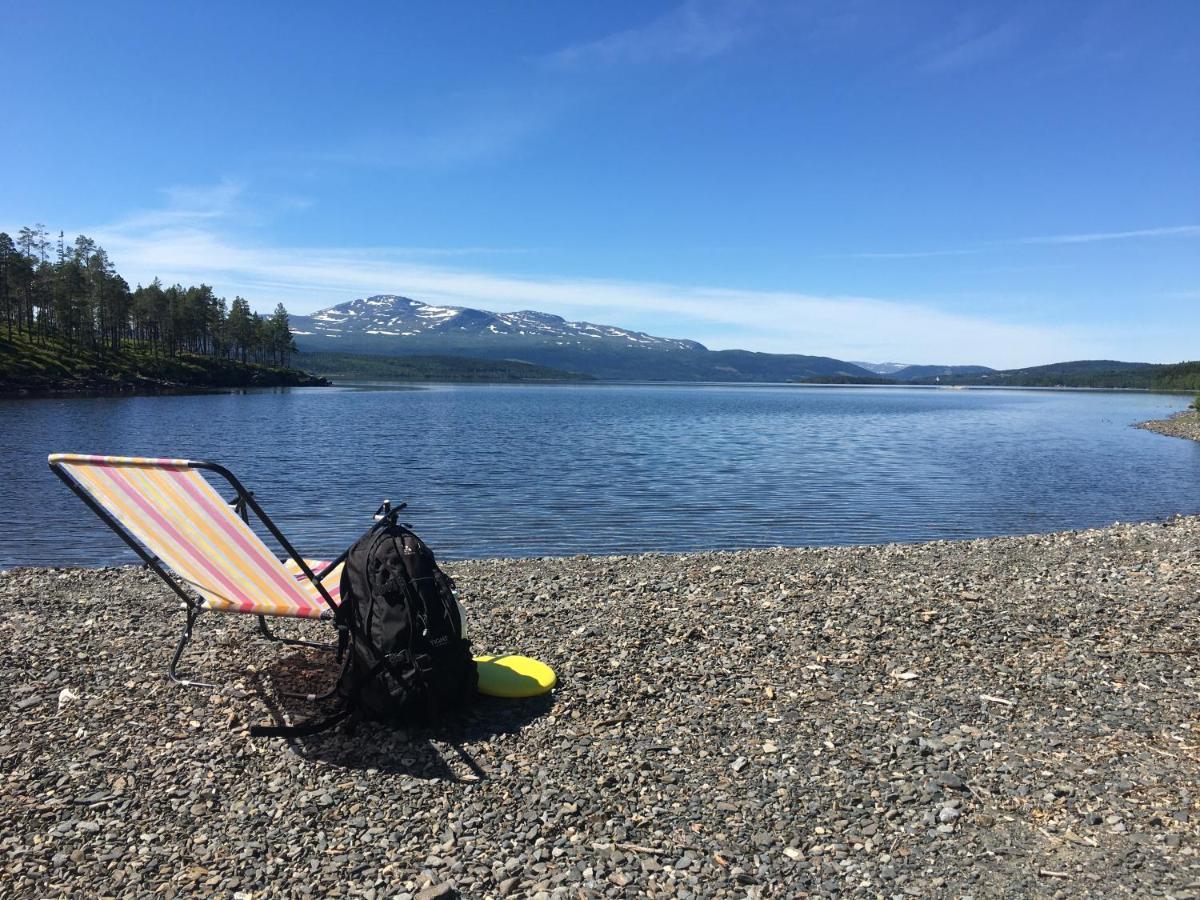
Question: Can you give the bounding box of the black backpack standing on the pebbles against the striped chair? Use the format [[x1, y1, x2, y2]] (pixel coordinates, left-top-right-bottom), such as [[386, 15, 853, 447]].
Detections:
[[337, 518, 479, 724]]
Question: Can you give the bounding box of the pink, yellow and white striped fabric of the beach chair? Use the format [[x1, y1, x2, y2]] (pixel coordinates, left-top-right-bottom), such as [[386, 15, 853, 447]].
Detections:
[[49, 454, 341, 619]]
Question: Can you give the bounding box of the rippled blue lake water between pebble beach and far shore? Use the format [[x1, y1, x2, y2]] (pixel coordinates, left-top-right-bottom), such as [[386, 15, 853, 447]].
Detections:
[[0, 385, 1200, 566]]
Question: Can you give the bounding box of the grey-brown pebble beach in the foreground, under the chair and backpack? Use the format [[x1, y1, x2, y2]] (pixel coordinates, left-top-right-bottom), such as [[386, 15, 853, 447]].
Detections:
[[0, 518, 1200, 898]]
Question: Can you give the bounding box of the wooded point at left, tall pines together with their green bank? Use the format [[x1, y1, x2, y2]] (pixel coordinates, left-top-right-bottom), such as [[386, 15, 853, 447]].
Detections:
[[0, 226, 319, 391]]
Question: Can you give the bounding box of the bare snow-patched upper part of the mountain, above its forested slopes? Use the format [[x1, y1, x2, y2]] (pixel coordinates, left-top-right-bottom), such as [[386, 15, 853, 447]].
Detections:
[[292, 294, 704, 352]]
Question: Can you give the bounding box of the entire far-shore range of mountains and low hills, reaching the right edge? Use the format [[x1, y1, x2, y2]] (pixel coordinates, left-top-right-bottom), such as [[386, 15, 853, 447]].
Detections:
[[292, 294, 1200, 389]]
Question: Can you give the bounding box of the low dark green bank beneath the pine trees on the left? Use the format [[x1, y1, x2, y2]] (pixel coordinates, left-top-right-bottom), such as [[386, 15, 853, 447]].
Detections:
[[0, 334, 325, 395]]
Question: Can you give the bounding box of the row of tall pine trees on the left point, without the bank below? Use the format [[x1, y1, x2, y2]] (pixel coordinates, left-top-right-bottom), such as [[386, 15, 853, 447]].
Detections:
[[0, 224, 296, 366]]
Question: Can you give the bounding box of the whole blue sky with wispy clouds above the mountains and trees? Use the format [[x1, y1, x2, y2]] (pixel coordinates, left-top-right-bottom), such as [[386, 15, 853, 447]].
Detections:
[[0, 0, 1200, 366]]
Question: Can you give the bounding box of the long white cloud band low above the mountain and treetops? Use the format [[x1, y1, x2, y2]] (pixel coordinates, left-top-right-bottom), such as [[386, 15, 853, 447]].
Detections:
[[84, 210, 1090, 366]]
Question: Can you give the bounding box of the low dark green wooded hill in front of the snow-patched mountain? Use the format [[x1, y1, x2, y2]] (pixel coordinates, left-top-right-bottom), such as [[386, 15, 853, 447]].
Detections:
[[295, 353, 594, 382]]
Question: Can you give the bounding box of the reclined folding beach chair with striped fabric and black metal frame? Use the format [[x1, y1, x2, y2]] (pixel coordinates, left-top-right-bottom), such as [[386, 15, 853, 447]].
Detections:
[[49, 454, 355, 688]]
